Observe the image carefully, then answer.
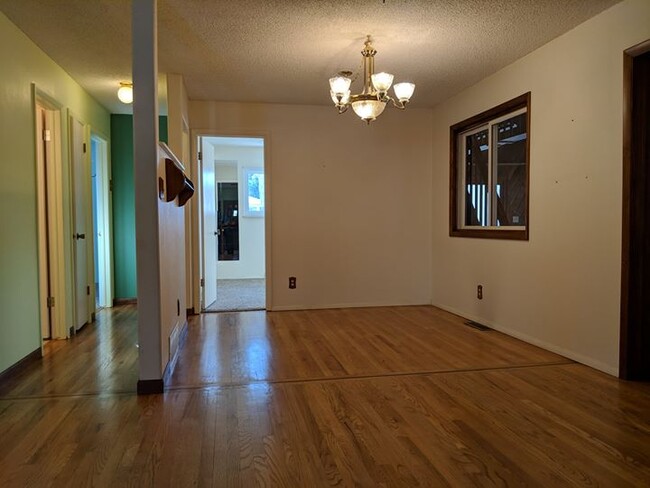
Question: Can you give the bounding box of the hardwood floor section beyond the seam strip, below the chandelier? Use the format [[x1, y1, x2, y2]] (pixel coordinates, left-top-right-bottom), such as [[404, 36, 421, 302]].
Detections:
[[170, 307, 570, 388]]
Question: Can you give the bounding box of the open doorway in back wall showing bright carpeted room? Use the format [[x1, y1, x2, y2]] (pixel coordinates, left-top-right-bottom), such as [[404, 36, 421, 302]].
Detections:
[[200, 136, 266, 312]]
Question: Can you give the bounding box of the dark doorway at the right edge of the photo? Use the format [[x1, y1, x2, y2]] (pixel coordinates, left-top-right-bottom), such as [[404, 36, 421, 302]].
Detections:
[[619, 40, 650, 381]]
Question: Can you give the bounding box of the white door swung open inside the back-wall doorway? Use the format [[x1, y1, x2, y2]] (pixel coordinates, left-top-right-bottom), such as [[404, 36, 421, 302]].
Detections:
[[201, 139, 218, 308]]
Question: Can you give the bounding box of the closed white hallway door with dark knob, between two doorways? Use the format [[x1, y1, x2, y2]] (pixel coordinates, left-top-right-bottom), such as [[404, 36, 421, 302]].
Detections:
[[71, 119, 92, 330]]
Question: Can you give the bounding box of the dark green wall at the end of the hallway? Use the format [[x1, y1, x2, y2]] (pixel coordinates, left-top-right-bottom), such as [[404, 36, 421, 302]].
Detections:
[[111, 114, 168, 299]]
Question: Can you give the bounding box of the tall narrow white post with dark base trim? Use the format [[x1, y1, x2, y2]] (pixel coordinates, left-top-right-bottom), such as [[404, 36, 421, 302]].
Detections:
[[132, 0, 164, 393]]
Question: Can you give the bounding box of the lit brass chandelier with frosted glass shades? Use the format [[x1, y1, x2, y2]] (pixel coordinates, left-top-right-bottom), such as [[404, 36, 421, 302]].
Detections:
[[330, 35, 415, 124]]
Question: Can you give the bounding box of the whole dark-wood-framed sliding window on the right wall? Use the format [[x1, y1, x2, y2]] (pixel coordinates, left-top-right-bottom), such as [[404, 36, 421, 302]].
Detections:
[[449, 92, 530, 240]]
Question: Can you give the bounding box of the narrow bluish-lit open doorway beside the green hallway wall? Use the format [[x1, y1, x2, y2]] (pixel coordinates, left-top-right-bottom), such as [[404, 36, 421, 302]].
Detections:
[[90, 134, 113, 310]]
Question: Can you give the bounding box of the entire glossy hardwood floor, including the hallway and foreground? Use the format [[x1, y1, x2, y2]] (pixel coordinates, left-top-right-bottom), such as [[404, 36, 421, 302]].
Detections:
[[0, 307, 650, 487]]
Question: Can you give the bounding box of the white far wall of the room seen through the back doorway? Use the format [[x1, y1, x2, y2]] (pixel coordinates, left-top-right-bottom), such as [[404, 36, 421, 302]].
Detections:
[[213, 144, 265, 280]]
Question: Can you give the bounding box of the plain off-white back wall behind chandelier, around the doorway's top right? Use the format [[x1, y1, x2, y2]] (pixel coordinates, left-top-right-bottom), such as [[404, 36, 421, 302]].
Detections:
[[189, 102, 432, 310]]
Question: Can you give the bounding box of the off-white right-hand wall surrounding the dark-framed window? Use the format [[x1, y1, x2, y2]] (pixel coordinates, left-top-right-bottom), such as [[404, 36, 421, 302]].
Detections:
[[432, 0, 650, 374]]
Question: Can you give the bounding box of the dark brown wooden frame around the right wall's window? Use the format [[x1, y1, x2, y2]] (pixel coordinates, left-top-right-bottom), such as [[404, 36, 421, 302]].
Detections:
[[449, 92, 531, 241]]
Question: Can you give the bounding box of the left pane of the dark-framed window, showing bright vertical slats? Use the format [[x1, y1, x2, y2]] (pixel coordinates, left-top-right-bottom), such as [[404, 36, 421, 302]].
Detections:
[[463, 129, 489, 226]]
